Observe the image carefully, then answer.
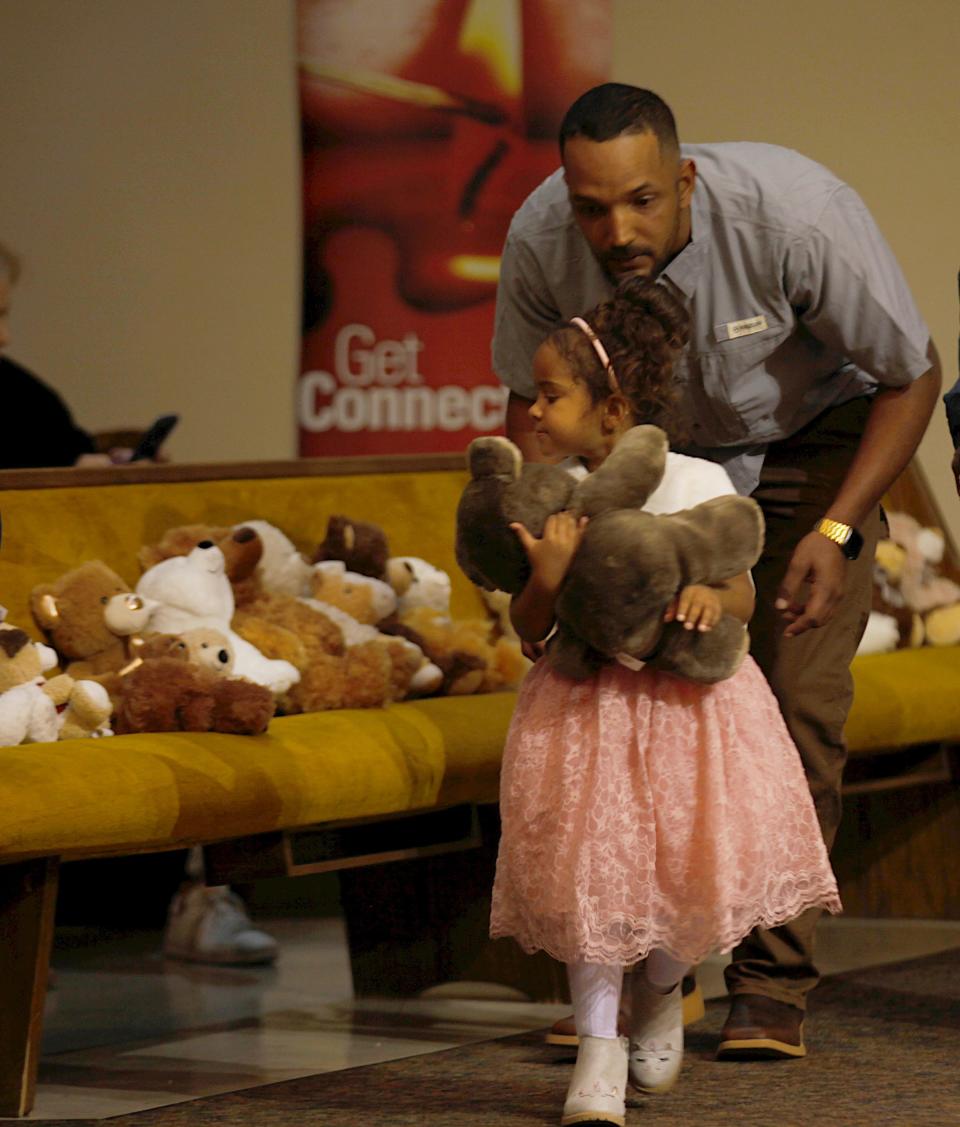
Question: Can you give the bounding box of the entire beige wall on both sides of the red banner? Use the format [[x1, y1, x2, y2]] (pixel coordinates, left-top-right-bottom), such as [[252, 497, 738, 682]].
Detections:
[[0, 0, 960, 539]]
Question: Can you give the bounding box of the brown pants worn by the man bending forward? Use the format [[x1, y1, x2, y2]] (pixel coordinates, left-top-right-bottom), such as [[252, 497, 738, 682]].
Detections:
[[726, 399, 881, 1009]]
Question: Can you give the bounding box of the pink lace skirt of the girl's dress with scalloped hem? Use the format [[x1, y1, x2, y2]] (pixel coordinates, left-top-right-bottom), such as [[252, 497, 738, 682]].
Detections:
[[490, 453, 841, 965]]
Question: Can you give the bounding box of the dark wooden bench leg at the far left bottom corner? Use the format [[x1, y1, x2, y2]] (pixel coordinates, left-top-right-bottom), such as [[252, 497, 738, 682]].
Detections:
[[0, 858, 60, 1116]]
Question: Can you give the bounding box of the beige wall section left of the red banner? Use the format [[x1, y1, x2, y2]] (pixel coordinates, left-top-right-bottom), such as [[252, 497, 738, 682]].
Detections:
[[0, 0, 300, 461]]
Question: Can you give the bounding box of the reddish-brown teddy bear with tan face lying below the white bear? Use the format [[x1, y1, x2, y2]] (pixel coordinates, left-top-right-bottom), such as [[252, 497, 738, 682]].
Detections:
[[115, 627, 275, 736]]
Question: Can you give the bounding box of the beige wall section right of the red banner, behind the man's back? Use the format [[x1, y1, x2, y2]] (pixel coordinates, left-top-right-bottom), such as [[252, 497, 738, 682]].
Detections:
[[613, 0, 960, 531]]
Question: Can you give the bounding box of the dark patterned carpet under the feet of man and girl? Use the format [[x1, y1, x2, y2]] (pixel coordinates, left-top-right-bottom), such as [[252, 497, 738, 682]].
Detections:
[[74, 950, 960, 1127]]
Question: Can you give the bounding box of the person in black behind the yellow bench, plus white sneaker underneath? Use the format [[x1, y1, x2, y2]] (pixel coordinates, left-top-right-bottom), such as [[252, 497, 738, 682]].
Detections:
[[0, 242, 277, 965]]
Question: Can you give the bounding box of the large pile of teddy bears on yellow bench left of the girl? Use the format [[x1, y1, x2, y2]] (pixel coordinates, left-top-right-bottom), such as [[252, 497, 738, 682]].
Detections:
[[0, 516, 528, 746]]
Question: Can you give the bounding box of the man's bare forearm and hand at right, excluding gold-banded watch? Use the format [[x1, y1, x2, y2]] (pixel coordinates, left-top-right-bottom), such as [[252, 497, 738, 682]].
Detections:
[[776, 343, 941, 636]]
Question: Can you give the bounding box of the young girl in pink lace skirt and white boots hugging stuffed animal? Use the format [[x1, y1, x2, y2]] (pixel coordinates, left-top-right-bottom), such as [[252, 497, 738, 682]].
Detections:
[[490, 279, 839, 1125]]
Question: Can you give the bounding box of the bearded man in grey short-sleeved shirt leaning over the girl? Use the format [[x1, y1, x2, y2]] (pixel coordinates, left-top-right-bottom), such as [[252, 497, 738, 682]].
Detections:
[[492, 83, 940, 1057]]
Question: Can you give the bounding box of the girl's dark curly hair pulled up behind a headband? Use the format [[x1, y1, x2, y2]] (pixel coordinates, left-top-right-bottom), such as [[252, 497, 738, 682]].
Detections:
[[550, 277, 690, 444]]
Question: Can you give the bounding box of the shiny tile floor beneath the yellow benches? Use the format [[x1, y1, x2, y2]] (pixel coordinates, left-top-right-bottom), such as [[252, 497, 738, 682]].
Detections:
[[11, 916, 960, 1122]]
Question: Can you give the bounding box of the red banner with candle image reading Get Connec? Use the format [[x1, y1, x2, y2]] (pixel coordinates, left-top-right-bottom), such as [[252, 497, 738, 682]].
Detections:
[[297, 0, 612, 458]]
